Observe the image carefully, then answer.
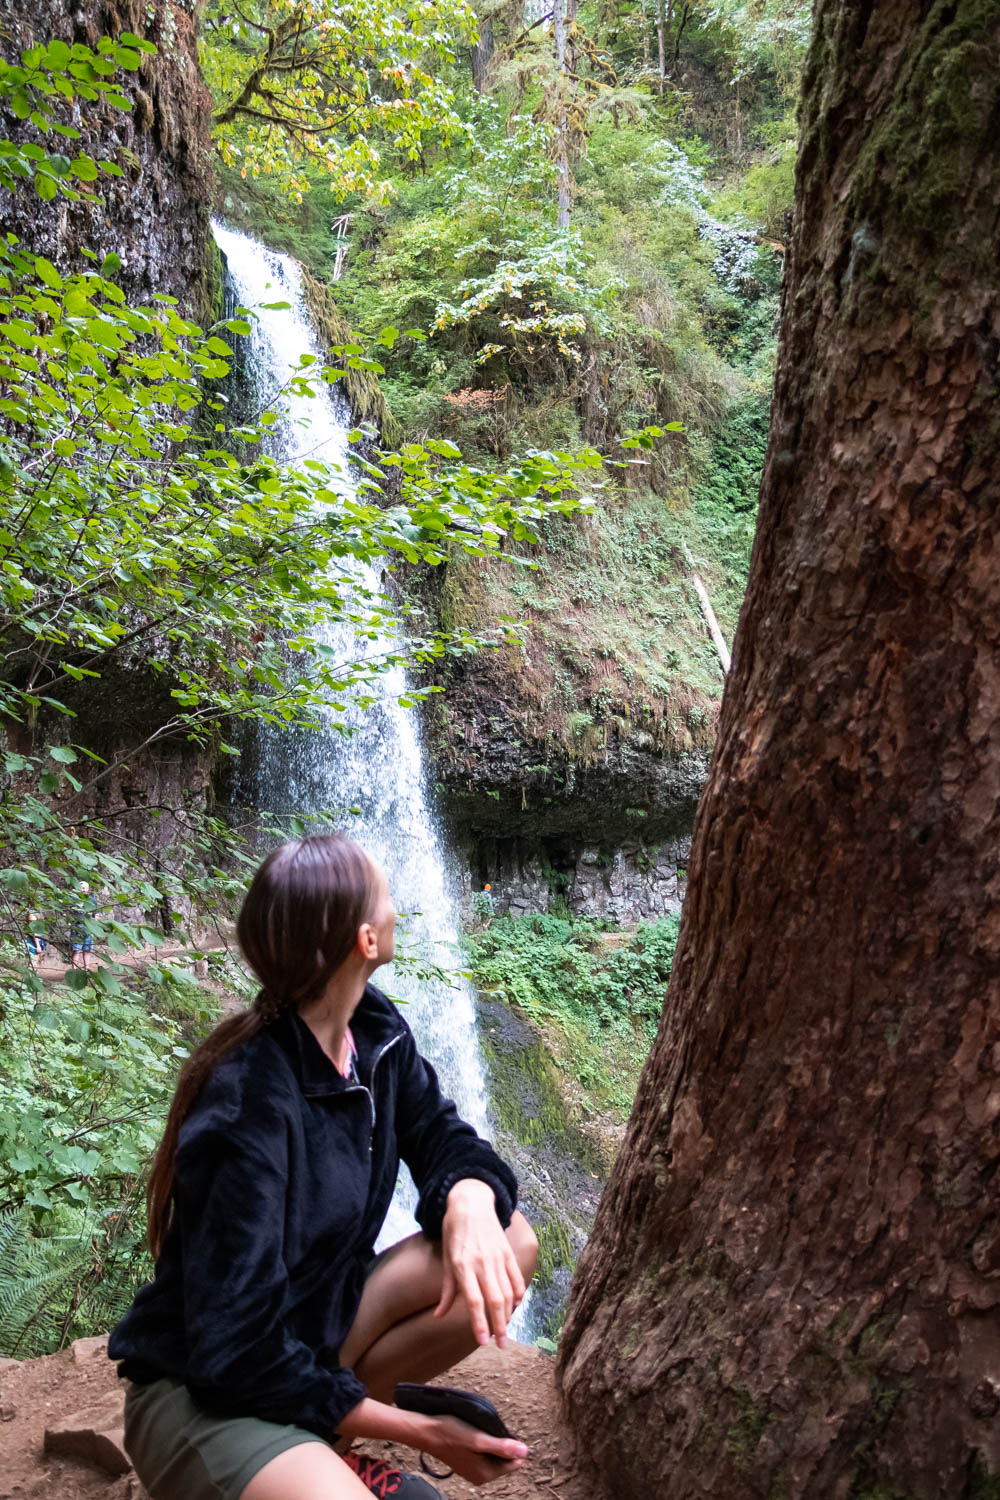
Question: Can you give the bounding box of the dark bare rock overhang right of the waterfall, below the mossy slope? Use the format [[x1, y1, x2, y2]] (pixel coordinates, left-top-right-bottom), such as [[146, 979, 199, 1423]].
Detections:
[[424, 657, 708, 926]]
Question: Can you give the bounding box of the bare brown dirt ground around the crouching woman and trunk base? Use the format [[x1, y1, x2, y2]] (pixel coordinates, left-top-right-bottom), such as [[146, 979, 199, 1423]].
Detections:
[[0, 1340, 600, 1500]]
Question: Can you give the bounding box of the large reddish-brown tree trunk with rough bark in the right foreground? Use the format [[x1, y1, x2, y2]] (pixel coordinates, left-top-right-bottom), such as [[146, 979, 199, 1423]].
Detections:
[[559, 0, 1000, 1500]]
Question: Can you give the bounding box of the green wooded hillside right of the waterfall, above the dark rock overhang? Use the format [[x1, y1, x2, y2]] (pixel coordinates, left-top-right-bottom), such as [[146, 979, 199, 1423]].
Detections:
[[212, 5, 805, 747]]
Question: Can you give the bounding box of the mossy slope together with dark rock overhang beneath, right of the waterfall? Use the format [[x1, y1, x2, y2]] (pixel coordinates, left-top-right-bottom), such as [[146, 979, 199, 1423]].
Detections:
[[407, 494, 742, 923]]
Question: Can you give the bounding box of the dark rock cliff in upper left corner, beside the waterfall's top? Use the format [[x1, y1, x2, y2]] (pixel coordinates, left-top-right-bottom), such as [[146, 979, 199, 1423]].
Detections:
[[0, 0, 211, 317]]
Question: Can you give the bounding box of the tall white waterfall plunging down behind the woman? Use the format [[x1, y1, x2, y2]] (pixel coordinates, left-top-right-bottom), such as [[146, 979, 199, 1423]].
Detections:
[[214, 225, 515, 1266]]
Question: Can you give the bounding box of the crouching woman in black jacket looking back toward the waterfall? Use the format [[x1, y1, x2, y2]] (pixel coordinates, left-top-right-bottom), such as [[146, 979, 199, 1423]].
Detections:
[[108, 834, 537, 1500]]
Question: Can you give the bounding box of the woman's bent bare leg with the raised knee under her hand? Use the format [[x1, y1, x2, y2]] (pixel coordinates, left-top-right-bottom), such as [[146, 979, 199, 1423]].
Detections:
[[340, 1214, 538, 1403]]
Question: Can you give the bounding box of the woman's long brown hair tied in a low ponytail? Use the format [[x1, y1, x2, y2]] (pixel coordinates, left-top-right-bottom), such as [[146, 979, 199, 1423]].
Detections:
[[145, 834, 376, 1257]]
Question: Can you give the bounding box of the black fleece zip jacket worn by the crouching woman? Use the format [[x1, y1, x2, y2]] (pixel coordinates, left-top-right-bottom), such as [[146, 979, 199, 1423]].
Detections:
[[108, 984, 517, 1439]]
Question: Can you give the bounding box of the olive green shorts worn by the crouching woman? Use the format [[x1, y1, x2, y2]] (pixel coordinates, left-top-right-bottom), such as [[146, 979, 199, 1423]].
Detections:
[[124, 1380, 328, 1500]]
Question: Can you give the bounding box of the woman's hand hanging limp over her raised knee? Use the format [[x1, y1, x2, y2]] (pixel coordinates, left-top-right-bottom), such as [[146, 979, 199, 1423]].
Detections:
[[433, 1178, 525, 1350]]
